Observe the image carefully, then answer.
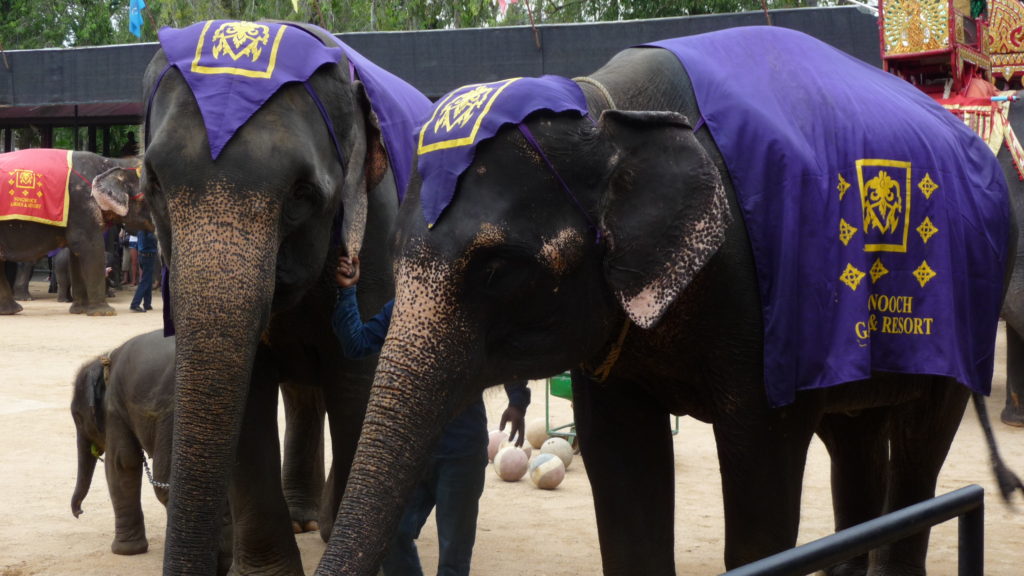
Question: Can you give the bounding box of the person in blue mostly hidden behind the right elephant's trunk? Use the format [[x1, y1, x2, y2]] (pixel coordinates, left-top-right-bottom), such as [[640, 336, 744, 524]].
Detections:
[[331, 256, 529, 576]]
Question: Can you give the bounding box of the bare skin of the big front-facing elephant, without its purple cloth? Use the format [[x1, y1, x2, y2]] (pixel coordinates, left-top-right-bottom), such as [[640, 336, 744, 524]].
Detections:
[[142, 22, 411, 575]]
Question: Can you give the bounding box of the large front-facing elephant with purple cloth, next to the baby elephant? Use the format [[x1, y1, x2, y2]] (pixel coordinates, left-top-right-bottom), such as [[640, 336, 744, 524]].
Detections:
[[141, 20, 430, 575]]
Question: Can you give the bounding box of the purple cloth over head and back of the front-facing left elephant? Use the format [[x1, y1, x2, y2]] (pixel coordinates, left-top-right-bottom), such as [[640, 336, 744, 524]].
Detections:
[[154, 20, 431, 200]]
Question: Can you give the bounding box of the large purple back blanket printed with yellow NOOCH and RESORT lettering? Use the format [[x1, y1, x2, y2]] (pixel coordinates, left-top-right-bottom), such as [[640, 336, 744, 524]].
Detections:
[[648, 27, 1011, 406]]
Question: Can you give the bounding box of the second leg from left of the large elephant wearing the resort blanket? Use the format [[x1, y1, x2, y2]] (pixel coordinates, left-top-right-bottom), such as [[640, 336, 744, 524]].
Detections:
[[714, 393, 820, 570]]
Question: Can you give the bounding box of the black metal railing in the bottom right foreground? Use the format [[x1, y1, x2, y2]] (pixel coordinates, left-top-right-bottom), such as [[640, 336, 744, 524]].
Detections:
[[723, 484, 985, 576]]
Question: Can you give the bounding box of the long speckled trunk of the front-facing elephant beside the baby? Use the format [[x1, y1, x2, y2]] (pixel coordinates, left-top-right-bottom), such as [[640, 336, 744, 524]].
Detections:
[[164, 213, 278, 575]]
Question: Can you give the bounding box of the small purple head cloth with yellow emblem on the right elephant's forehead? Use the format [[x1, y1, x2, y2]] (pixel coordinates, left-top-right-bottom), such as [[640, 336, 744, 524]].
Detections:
[[416, 76, 587, 227]]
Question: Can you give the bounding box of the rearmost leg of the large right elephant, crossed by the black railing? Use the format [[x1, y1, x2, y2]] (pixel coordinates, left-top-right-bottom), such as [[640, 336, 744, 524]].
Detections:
[[870, 378, 970, 576]]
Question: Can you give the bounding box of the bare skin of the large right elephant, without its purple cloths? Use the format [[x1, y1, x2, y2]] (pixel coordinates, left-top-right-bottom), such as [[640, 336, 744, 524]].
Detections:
[[318, 41, 1016, 575]]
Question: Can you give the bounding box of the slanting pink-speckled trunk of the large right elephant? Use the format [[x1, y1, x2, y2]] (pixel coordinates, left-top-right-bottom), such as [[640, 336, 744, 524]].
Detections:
[[316, 268, 472, 576]]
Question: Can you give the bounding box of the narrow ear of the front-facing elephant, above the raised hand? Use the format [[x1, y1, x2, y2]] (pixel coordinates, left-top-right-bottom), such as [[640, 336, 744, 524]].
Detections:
[[341, 82, 388, 255]]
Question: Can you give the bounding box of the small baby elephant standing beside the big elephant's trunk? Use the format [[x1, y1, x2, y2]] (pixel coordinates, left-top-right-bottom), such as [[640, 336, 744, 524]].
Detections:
[[71, 330, 231, 574]]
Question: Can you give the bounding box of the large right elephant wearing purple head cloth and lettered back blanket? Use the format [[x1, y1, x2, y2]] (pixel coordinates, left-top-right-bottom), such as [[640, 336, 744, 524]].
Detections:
[[317, 28, 1017, 575]]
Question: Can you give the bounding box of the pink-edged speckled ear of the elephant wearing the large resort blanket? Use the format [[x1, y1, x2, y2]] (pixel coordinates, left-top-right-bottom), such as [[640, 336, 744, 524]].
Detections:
[[598, 111, 730, 328]]
